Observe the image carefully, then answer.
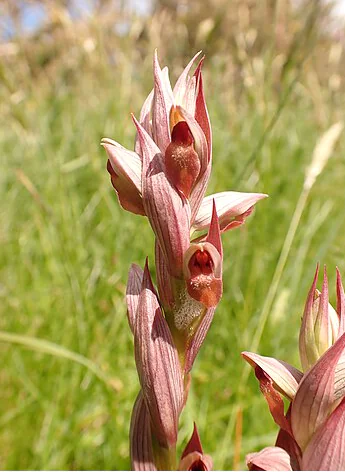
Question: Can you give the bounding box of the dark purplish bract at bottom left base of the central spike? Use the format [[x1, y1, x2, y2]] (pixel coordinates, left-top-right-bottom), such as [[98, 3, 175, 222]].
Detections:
[[129, 391, 157, 471]]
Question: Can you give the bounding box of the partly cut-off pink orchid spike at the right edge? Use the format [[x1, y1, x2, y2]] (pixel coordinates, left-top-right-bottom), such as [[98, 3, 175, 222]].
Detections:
[[242, 268, 345, 470]]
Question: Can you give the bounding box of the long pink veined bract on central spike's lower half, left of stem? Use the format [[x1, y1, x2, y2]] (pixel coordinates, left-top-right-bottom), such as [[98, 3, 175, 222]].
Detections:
[[134, 263, 183, 448]]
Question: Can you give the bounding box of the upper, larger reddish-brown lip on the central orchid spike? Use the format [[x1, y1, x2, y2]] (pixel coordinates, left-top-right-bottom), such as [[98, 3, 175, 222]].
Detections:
[[165, 121, 200, 198]]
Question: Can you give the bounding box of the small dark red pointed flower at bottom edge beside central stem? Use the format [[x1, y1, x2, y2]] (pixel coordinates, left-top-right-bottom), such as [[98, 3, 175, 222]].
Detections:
[[179, 423, 213, 470]]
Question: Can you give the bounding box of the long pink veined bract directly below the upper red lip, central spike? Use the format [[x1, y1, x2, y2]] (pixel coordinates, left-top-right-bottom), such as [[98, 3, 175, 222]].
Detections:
[[133, 117, 190, 277]]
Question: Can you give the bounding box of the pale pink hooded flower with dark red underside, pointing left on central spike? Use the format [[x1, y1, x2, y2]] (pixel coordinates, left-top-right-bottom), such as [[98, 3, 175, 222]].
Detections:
[[101, 138, 145, 215]]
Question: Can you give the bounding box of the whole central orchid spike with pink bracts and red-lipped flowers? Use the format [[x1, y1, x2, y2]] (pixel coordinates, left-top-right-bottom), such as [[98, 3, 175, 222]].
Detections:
[[102, 53, 266, 470]]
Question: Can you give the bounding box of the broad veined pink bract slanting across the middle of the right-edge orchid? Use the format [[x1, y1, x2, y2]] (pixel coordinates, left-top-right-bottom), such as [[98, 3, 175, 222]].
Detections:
[[291, 334, 345, 451]]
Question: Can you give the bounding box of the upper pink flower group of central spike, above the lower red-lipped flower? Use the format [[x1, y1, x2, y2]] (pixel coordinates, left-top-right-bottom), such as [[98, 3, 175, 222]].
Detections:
[[102, 53, 267, 277]]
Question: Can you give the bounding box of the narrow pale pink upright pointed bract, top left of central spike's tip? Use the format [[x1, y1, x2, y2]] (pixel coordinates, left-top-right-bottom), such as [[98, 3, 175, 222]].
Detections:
[[152, 51, 173, 154]]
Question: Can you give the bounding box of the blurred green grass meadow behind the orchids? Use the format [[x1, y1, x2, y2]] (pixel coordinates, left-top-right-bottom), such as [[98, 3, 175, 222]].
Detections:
[[0, 1, 345, 470]]
